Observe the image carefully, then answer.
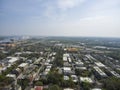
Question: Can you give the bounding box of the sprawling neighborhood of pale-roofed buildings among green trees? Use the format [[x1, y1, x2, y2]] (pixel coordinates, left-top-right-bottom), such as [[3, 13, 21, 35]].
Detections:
[[0, 38, 120, 90]]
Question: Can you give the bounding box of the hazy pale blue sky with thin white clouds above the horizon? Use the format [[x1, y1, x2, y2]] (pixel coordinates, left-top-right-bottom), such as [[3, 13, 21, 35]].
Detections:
[[0, 0, 120, 37]]
